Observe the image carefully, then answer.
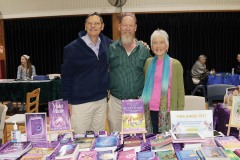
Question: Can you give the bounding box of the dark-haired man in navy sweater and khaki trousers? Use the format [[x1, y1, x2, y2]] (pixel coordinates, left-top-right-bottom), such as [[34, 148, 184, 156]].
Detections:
[[61, 12, 112, 133]]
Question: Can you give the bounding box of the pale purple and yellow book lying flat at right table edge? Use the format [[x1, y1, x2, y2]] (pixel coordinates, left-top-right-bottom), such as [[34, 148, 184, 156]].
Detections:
[[214, 136, 240, 151]]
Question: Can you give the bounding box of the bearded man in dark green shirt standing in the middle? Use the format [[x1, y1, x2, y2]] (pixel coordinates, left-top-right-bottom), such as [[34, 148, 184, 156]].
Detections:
[[108, 13, 151, 131]]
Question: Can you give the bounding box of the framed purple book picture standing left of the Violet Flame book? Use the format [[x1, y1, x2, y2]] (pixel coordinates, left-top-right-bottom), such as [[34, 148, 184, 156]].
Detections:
[[25, 113, 47, 143]]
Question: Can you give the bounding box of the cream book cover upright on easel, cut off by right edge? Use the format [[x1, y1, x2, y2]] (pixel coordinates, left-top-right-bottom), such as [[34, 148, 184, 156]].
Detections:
[[229, 96, 240, 126]]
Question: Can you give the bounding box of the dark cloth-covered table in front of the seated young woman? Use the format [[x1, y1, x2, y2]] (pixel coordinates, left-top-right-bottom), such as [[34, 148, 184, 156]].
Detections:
[[0, 79, 61, 104]]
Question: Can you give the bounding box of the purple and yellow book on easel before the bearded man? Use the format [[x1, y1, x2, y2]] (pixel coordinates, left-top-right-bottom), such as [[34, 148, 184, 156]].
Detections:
[[122, 99, 146, 133]]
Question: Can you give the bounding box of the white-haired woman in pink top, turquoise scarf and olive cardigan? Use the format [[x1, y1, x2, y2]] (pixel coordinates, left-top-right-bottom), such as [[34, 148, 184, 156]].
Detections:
[[141, 29, 185, 134]]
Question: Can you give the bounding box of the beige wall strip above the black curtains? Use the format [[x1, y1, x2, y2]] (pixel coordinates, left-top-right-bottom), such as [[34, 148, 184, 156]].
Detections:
[[0, 0, 240, 19]]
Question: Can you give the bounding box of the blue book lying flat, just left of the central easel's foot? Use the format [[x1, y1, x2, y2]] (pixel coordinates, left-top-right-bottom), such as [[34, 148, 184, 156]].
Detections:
[[95, 136, 118, 151]]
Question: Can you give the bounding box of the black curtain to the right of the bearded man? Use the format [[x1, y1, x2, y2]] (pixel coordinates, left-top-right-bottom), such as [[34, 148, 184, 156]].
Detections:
[[136, 12, 240, 73]]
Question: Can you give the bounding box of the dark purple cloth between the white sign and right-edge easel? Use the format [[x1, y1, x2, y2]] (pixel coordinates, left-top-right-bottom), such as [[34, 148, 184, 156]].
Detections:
[[213, 103, 239, 138]]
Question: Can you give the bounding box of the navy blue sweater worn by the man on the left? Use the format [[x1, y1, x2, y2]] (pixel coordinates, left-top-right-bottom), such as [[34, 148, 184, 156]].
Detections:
[[61, 31, 112, 104]]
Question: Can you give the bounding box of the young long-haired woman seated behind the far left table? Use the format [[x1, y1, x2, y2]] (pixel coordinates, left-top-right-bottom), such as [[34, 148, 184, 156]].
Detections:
[[17, 55, 36, 80]]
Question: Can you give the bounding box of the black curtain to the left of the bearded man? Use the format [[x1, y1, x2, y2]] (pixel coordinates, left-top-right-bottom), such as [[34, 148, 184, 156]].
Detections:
[[4, 15, 112, 78]]
